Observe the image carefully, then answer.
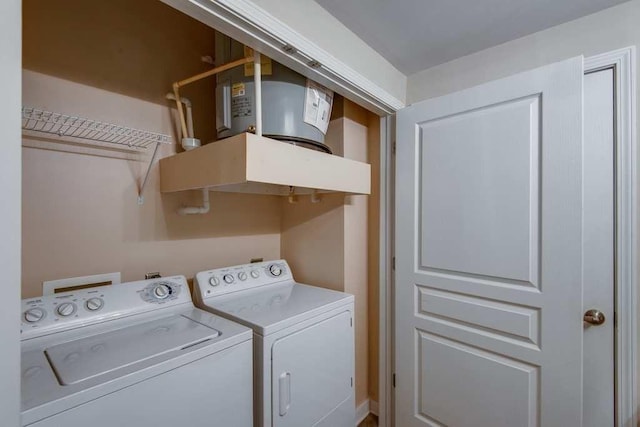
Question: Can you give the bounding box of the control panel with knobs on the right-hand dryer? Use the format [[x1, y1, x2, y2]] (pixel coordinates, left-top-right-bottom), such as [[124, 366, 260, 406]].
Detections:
[[196, 259, 293, 301]]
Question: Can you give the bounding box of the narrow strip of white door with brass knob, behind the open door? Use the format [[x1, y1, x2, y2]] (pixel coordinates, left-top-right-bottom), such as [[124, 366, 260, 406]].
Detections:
[[583, 69, 615, 427]]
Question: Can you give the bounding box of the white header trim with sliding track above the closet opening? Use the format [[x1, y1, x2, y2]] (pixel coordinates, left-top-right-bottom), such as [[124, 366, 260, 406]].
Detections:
[[162, 0, 405, 114]]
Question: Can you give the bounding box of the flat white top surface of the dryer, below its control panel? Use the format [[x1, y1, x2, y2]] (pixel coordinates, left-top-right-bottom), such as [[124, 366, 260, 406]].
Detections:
[[204, 282, 353, 335]]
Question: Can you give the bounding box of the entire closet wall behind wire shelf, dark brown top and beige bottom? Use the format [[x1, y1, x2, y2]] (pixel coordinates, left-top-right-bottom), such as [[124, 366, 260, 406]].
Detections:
[[22, 0, 281, 297]]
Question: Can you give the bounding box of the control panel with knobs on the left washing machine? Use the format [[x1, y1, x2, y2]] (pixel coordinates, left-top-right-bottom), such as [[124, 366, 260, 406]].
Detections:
[[21, 276, 191, 339]]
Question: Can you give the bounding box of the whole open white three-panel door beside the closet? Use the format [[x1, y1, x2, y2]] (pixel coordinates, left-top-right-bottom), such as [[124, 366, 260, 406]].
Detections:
[[395, 57, 583, 427]]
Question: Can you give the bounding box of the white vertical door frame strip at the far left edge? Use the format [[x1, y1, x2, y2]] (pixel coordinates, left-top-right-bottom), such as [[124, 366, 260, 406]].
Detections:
[[0, 0, 22, 427]]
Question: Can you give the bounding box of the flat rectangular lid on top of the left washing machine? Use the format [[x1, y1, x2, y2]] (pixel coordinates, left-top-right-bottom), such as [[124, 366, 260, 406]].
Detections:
[[45, 315, 220, 385]]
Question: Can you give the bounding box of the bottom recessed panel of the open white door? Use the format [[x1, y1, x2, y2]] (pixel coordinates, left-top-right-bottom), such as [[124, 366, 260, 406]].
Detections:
[[418, 332, 540, 427]]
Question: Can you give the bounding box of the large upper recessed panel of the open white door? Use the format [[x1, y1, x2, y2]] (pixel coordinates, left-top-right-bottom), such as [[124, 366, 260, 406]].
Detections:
[[418, 96, 540, 286]]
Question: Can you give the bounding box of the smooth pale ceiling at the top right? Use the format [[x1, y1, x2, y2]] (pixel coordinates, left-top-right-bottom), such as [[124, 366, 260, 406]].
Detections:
[[315, 0, 627, 75]]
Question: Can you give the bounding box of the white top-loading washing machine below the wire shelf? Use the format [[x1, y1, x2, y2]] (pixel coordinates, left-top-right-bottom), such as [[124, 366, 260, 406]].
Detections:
[[22, 276, 253, 427]]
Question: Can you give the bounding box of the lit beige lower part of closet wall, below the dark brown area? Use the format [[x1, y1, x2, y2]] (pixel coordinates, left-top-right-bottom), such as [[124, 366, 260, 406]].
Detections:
[[22, 71, 281, 298]]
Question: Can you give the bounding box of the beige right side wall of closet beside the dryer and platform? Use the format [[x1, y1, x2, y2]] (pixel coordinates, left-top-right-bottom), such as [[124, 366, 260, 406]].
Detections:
[[281, 113, 370, 405]]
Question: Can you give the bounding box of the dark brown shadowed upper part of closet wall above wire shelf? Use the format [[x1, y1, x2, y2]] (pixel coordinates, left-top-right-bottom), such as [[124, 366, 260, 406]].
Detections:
[[22, 0, 216, 142]]
